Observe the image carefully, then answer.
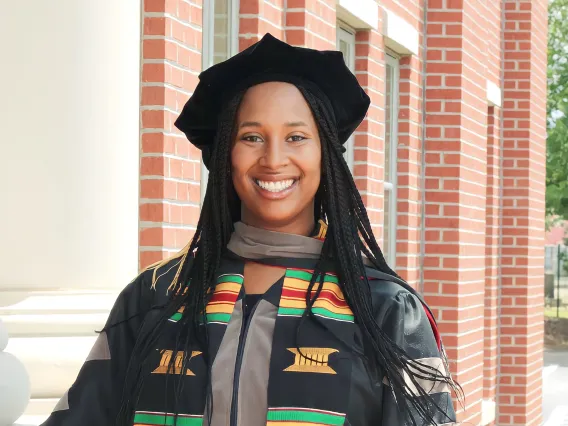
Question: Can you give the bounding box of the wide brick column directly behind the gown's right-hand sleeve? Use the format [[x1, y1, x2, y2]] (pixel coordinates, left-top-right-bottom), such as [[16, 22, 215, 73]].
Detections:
[[424, 0, 487, 424]]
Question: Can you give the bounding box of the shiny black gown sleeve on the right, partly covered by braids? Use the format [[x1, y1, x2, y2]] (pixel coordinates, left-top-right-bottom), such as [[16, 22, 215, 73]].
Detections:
[[377, 283, 457, 426]]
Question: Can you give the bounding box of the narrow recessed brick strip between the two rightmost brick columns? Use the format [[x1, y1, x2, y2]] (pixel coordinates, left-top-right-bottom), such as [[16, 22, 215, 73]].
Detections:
[[483, 107, 502, 400]]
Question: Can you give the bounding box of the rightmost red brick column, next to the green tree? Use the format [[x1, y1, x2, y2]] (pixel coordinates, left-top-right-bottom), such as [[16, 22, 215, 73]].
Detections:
[[498, 0, 548, 426]]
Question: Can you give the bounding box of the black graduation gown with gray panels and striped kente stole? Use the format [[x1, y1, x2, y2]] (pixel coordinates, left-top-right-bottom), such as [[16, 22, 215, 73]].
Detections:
[[43, 255, 455, 426]]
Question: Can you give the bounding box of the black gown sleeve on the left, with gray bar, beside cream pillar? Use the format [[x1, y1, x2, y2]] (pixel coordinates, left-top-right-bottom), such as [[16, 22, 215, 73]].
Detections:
[[42, 274, 151, 426]]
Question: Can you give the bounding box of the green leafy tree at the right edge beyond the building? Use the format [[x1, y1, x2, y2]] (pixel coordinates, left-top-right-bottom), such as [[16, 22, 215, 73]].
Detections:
[[546, 0, 568, 219]]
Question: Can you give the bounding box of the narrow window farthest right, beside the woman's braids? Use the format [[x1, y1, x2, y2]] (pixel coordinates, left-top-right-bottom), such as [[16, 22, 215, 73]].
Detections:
[[383, 55, 399, 267]]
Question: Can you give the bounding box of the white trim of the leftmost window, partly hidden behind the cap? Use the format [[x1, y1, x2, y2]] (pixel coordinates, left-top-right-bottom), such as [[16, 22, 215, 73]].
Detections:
[[200, 0, 240, 205]]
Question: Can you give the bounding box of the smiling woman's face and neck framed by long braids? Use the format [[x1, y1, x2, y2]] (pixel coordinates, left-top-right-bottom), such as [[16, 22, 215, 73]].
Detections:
[[231, 82, 321, 235]]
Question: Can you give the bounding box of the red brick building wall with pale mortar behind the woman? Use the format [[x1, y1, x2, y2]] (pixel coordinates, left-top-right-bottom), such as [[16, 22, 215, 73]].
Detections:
[[134, 0, 546, 425]]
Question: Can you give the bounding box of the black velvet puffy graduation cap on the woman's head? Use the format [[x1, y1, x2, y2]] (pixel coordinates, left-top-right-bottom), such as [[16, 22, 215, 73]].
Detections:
[[175, 34, 370, 168]]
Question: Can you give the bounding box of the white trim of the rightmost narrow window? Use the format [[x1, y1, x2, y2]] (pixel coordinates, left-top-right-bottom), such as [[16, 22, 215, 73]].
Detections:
[[383, 54, 400, 268]]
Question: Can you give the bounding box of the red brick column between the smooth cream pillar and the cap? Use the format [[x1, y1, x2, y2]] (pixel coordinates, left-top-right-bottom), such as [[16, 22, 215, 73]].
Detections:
[[140, 0, 202, 267]]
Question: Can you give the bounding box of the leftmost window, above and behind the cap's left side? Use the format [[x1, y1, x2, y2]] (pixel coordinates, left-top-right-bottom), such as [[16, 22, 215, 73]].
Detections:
[[201, 0, 239, 203]]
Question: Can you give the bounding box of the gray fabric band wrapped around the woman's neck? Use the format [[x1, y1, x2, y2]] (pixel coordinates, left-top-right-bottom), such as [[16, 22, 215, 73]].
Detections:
[[227, 222, 323, 259]]
